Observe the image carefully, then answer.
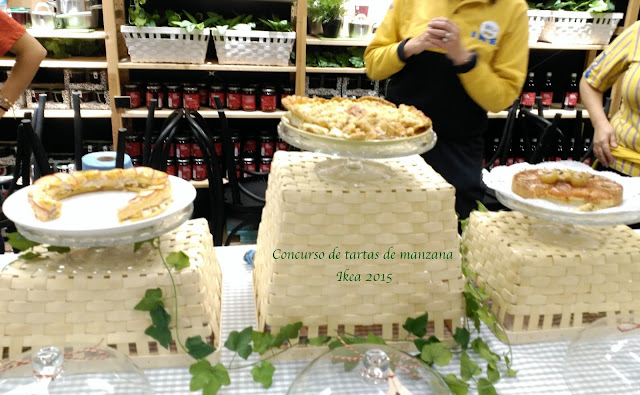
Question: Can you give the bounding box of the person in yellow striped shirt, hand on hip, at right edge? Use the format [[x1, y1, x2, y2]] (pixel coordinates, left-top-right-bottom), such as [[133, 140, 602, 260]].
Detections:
[[580, 22, 640, 177]]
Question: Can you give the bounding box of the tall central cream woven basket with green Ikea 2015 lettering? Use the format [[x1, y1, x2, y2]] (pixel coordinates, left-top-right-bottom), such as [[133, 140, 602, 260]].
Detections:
[[253, 151, 464, 340]]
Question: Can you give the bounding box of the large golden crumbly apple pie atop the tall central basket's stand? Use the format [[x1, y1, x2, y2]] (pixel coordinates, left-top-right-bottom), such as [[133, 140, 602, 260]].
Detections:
[[282, 95, 431, 140]]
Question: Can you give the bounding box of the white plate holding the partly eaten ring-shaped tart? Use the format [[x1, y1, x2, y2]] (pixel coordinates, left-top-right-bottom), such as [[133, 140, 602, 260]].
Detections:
[[2, 176, 196, 246]]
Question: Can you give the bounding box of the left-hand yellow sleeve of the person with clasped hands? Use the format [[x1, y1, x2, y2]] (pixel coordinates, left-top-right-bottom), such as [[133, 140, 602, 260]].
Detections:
[[364, 0, 405, 80]]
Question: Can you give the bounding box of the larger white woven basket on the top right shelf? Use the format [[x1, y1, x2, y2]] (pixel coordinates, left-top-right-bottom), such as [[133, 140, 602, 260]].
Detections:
[[540, 11, 624, 45]]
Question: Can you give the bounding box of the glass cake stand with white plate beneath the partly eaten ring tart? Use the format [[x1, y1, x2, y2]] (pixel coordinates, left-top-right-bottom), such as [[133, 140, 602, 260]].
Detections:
[[2, 176, 196, 268]]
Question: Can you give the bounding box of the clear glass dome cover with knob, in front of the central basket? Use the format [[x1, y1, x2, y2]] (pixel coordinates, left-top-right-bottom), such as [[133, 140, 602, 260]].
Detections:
[[287, 344, 450, 395]]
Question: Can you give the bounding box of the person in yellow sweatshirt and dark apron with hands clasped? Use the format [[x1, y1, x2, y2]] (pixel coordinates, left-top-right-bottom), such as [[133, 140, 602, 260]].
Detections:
[[364, 0, 529, 219]]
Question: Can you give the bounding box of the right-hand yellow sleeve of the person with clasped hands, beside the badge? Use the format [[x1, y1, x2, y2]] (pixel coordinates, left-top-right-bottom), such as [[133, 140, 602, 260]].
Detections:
[[459, 2, 529, 112]]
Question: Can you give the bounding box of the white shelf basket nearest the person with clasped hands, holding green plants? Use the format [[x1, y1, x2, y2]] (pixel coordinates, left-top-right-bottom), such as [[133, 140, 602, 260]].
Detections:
[[212, 30, 296, 66]]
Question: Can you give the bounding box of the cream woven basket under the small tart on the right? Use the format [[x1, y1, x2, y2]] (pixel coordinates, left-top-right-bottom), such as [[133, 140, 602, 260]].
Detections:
[[463, 211, 640, 343]]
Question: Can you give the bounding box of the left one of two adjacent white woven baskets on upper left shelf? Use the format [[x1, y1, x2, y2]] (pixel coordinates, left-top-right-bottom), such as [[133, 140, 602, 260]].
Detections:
[[120, 25, 211, 63]]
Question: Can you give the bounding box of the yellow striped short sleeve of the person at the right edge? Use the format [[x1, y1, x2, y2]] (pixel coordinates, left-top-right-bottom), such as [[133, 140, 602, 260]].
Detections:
[[584, 22, 640, 92]]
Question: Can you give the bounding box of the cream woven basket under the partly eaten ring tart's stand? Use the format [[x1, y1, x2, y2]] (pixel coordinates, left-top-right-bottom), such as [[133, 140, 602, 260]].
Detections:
[[0, 219, 222, 367]]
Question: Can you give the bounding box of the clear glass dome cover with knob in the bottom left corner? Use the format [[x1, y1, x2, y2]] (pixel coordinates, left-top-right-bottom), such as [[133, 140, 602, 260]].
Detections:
[[0, 345, 152, 395]]
